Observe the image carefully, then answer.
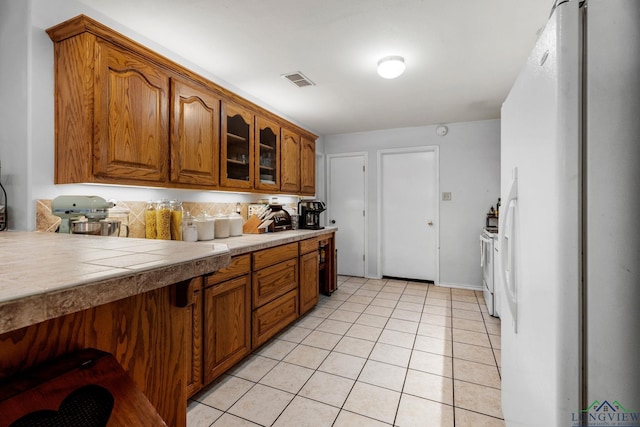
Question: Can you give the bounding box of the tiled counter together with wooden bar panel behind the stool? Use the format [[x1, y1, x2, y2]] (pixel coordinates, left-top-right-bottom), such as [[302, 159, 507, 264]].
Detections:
[[0, 228, 336, 427]]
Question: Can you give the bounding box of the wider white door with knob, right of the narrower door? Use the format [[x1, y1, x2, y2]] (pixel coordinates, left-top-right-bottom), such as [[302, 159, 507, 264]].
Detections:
[[378, 147, 438, 283]]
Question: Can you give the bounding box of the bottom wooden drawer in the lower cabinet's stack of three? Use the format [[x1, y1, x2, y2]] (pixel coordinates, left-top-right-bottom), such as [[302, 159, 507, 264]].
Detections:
[[251, 289, 298, 349]]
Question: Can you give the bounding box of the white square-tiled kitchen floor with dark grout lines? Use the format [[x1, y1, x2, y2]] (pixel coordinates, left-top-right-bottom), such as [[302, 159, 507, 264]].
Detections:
[[187, 276, 504, 427]]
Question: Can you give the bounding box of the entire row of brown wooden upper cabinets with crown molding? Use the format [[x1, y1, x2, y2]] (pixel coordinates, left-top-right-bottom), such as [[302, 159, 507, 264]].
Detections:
[[47, 15, 315, 195]]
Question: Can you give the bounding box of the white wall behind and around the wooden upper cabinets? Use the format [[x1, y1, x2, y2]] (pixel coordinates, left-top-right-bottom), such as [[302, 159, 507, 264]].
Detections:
[[0, 0, 305, 231]]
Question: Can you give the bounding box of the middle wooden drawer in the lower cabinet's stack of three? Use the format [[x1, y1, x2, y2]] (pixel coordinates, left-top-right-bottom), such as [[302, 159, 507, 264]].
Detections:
[[252, 258, 298, 308]]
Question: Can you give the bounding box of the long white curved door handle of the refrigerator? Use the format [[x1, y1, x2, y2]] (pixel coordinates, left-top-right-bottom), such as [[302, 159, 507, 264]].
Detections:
[[499, 168, 518, 333]]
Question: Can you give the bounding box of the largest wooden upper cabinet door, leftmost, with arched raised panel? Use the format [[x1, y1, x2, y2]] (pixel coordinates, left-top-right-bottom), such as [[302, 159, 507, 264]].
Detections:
[[93, 41, 169, 182]]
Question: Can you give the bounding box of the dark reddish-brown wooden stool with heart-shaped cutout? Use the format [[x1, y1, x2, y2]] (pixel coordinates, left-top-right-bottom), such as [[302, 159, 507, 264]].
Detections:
[[0, 349, 166, 427]]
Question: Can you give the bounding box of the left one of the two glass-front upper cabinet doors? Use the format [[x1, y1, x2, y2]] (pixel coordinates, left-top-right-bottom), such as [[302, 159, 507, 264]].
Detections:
[[220, 102, 253, 188]]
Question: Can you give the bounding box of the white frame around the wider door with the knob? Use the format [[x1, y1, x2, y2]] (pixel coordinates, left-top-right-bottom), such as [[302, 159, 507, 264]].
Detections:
[[376, 145, 440, 285]]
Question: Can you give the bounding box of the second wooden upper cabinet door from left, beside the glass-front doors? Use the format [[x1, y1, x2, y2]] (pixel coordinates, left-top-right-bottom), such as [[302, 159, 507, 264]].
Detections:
[[170, 79, 220, 187]]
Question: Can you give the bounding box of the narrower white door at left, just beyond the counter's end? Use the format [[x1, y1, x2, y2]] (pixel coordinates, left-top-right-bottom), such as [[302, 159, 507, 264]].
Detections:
[[327, 153, 365, 277]]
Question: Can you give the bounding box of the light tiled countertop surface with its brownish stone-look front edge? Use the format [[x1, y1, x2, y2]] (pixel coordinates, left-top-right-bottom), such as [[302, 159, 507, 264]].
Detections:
[[0, 228, 336, 333]]
